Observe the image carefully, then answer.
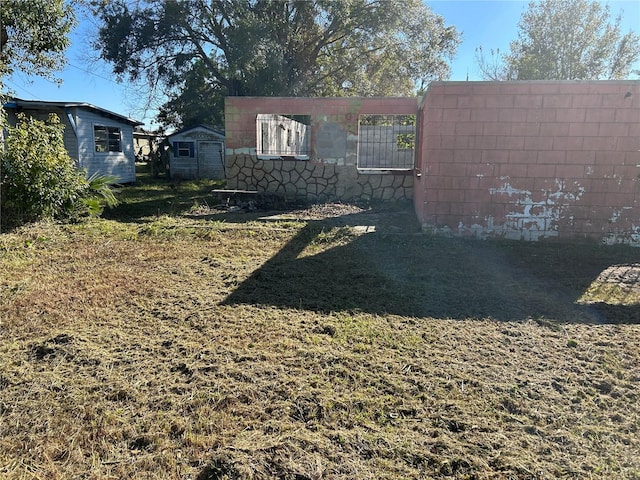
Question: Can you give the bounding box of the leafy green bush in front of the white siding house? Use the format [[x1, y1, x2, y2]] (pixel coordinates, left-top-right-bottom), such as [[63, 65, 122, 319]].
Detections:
[[0, 113, 117, 231]]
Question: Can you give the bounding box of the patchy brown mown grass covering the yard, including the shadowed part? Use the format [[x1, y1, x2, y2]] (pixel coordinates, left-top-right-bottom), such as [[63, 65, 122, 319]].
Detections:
[[0, 183, 640, 480]]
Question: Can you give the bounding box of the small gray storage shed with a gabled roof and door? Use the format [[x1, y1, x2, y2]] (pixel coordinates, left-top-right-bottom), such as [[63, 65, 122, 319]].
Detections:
[[167, 125, 225, 180]]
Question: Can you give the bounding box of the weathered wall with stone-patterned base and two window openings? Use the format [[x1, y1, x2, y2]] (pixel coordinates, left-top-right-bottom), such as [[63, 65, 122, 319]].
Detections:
[[225, 97, 418, 201]]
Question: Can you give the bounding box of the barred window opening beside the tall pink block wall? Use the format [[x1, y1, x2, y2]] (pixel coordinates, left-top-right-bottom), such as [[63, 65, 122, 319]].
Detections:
[[358, 115, 416, 171]]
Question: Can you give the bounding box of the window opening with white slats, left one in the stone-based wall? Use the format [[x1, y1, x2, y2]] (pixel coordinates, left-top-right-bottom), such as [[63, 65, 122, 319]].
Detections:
[[256, 114, 311, 160]]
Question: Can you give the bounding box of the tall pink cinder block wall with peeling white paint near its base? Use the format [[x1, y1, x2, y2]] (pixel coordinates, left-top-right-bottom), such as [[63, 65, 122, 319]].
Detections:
[[414, 81, 640, 245]]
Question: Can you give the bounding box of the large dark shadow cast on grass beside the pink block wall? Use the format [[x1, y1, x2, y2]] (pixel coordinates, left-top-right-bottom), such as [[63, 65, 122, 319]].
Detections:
[[224, 215, 640, 323]]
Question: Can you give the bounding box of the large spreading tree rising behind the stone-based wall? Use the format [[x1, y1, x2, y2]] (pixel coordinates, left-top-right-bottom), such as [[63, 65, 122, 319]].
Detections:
[[94, 0, 460, 128]]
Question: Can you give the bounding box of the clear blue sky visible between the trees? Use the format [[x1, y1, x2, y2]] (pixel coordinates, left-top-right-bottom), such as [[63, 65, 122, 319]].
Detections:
[[5, 0, 640, 129]]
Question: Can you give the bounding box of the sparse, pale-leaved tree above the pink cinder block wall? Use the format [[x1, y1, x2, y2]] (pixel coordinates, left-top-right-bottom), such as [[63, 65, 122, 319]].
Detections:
[[476, 0, 640, 80]]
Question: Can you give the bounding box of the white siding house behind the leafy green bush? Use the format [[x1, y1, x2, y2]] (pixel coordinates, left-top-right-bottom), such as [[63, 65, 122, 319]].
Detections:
[[4, 98, 142, 183]]
